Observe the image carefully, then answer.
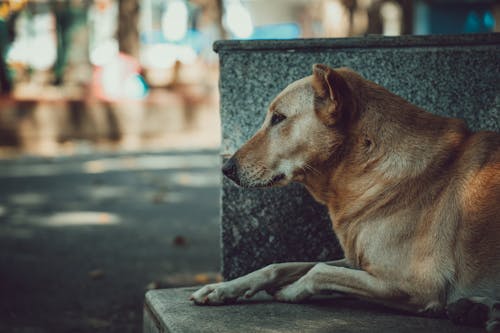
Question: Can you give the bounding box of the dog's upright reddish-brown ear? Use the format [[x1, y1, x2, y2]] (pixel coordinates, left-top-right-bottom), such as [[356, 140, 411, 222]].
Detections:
[[312, 64, 347, 126]]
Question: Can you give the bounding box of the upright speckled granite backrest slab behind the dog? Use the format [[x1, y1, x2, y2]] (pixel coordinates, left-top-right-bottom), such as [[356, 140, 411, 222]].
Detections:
[[215, 34, 500, 278]]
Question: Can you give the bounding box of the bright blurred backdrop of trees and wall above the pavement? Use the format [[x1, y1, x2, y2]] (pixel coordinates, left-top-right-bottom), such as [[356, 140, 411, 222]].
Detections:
[[0, 0, 500, 155]]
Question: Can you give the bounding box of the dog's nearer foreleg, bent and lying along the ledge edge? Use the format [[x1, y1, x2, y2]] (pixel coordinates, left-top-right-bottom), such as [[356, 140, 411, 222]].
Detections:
[[275, 263, 406, 309]]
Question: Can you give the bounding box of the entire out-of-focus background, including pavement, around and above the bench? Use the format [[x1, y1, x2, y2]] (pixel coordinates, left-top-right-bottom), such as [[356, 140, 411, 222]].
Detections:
[[0, 0, 500, 333]]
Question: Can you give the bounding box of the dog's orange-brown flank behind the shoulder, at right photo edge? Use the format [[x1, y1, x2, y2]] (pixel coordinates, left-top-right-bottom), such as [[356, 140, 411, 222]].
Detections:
[[450, 132, 500, 300]]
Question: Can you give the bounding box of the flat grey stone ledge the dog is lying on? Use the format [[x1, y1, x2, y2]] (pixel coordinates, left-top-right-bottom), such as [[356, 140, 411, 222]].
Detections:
[[143, 288, 482, 333]]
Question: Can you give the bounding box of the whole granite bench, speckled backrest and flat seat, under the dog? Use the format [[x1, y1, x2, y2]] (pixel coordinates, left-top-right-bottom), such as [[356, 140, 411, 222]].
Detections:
[[145, 34, 500, 332]]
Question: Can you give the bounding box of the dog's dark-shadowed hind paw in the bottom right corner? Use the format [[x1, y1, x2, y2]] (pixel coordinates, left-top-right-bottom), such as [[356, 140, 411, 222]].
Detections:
[[446, 297, 500, 332]]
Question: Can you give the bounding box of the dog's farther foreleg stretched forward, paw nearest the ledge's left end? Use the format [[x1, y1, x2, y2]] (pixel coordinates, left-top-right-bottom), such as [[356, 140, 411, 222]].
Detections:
[[190, 259, 348, 305]]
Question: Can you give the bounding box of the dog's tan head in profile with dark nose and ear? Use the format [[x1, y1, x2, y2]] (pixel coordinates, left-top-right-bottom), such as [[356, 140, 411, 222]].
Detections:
[[222, 64, 349, 187]]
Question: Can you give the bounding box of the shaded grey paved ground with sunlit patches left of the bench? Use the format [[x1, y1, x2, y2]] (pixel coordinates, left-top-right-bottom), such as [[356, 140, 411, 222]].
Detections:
[[0, 150, 220, 333]]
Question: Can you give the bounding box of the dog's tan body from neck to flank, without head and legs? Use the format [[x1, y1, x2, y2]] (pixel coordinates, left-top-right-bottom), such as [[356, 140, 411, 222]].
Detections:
[[333, 69, 500, 304]]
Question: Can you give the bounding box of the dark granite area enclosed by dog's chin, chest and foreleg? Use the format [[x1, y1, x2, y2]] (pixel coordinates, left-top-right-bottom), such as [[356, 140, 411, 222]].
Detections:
[[222, 179, 342, 279]]
